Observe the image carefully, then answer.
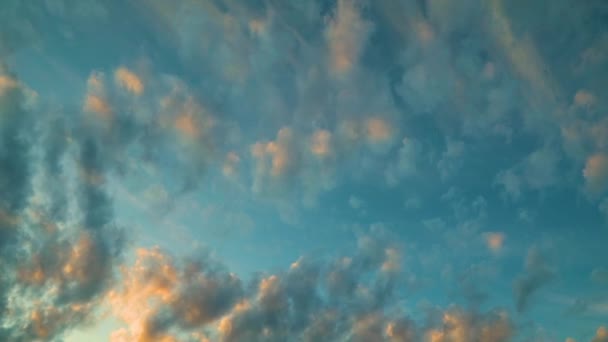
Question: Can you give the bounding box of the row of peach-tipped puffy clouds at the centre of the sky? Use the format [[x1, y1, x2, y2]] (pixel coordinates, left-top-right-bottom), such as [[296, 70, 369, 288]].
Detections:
[[249, 117, 402, 205]]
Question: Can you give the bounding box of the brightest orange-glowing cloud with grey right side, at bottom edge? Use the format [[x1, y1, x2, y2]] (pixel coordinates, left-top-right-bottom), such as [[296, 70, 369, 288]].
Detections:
[[107, 248, 242, 341]]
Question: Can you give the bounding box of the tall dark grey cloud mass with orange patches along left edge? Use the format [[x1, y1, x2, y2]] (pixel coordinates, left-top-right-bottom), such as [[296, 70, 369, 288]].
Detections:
[[0, 64, 123, 341]]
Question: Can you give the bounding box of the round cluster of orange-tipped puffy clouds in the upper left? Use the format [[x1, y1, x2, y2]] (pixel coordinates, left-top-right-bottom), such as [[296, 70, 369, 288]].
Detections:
[[76, 66, 224, 192]]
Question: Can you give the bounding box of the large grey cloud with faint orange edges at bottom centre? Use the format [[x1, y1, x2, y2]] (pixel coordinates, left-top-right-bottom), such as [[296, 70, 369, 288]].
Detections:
[[222, 230, 404, 341]]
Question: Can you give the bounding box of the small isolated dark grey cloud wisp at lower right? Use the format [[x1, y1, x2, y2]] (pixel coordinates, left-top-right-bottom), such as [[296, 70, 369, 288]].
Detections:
[[513, 248, 555, 312]]
